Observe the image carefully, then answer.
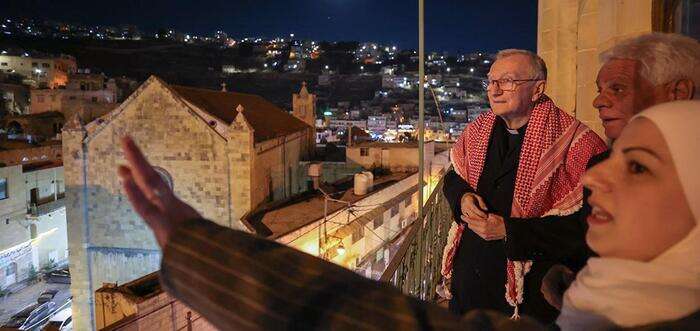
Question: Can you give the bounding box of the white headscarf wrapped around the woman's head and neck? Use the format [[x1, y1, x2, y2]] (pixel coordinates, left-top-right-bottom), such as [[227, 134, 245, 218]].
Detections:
[[557, 101, 700, 330]]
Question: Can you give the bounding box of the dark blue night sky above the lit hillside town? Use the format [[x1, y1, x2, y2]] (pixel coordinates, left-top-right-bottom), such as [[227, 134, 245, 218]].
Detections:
[[0, 0, 537, 52]]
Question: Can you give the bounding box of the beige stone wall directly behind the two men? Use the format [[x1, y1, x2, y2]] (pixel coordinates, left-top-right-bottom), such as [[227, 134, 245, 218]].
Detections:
[[537, 0, 652, 137]]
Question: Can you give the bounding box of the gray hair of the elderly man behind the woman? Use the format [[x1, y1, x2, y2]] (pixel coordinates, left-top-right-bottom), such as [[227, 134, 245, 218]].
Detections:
[[600, 33, 700, 99]]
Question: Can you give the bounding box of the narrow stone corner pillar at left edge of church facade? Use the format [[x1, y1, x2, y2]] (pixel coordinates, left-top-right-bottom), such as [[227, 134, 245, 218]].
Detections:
[[62, 115, 95, 330]]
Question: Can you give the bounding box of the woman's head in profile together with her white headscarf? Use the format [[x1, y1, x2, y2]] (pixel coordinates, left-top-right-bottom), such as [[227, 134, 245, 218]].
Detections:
[[557, 101, 700, 330]]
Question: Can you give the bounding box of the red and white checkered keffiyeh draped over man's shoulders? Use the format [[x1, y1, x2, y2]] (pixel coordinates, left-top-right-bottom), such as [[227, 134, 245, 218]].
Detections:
[[442, 96, 607, 318]]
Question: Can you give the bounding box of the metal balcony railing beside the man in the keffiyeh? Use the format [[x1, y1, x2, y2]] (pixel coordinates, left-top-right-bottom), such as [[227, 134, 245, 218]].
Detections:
[[380, 176, 453, 301]]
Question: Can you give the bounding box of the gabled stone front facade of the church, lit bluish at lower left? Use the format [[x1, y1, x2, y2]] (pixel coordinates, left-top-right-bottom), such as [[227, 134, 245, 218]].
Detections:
[[64, 80, 231, 330]]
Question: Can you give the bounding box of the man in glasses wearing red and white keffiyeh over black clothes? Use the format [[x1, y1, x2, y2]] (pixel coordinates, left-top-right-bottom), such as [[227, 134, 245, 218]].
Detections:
[[442, 49, 606, 323]]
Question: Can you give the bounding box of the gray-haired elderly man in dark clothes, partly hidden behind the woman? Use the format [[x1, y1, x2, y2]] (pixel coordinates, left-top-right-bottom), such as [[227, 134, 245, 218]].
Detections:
[[540, 33, 700, 308]]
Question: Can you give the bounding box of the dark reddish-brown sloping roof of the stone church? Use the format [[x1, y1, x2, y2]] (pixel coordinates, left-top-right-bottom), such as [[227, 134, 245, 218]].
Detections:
[[170, 85, 310, 142]]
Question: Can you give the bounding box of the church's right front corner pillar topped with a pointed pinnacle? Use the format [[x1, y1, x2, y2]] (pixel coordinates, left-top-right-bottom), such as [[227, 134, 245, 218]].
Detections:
[[226, 105, 255, 229]]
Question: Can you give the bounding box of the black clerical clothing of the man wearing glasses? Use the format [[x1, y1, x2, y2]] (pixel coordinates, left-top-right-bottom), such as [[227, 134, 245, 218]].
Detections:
[[445, 118, 557, 323]]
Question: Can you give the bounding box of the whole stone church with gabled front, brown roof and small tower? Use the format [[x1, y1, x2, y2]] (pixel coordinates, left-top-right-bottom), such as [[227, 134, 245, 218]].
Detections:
[[63, 76, 316, 330]]
